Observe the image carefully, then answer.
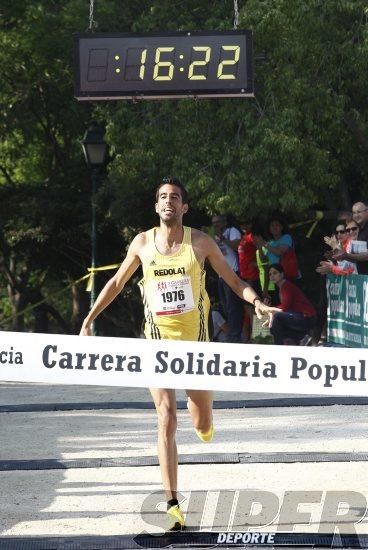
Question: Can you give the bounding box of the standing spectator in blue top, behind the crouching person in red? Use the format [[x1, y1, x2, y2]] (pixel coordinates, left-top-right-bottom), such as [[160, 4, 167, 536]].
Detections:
[[257, 215, 301, 281]]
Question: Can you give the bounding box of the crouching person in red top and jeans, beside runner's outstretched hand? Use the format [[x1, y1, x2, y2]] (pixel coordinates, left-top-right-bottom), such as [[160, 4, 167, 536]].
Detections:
[[268, 264, 316, 346]]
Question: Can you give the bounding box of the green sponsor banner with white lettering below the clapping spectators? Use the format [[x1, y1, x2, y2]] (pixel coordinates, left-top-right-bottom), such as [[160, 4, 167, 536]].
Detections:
[[326, 275, 368, 348]]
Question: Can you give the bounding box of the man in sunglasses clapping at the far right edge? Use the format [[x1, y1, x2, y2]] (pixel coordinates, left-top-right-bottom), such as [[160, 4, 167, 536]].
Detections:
[[333, 201, 368, 275]]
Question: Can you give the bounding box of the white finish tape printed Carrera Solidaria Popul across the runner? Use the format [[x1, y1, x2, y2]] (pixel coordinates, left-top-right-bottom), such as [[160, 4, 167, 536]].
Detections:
[[0, 331, 368, 396]]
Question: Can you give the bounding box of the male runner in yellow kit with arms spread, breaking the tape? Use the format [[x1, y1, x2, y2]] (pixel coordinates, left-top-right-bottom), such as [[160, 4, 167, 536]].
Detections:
[[81, 178, 274, 530]]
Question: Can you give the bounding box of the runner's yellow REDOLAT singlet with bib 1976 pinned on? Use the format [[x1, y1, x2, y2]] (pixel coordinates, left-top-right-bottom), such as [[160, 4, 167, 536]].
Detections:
[[139, 227, 210, 342]]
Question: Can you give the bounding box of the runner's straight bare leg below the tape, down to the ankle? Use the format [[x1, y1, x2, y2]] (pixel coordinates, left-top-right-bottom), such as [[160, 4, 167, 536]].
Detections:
[[150, 388, 178, 500]]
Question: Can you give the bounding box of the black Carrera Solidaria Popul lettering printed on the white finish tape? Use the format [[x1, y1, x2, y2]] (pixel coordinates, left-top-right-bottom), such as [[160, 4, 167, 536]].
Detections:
[[0, 345, 368, 387]]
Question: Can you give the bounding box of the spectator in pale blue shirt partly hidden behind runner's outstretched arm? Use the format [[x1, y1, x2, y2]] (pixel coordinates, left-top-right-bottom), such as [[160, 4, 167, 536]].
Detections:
[[212, 215, 244, 343]]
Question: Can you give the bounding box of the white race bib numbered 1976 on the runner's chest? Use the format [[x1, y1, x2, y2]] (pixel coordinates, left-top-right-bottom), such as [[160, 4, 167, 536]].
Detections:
[[152, 277, 194, 315]]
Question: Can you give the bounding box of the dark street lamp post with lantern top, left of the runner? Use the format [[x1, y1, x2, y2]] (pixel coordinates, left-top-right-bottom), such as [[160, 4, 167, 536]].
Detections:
[[82, 126, 107, 335]]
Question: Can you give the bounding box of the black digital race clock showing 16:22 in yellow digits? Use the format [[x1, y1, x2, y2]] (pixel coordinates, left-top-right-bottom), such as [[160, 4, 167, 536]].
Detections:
[[74, 30, 254, 100]]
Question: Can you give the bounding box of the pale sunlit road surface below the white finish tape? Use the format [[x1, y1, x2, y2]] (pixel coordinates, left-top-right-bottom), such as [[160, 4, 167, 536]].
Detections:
[[0, 382, 368, 548]]
